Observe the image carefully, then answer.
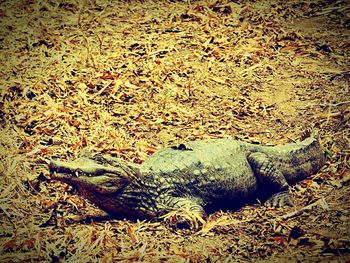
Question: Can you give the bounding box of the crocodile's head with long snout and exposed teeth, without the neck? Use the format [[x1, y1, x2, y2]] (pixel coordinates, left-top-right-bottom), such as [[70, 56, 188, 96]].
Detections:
[[49, 156, 135, 198]]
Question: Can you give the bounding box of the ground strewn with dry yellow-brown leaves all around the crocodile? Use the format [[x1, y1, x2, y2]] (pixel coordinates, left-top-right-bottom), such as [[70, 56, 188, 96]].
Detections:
[[0, 0, 350, 262]]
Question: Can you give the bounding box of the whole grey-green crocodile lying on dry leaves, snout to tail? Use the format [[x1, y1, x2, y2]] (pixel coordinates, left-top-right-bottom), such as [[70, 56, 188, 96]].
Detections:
[[49, 131, 325, 222]]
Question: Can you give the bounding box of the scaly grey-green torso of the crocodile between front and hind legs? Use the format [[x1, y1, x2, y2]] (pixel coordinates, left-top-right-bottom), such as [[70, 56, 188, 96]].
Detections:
[[140, 139, 256, 204]]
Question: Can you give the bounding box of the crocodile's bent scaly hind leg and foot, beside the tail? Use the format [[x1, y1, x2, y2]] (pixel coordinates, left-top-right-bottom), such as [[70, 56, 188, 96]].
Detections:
[[247, 152, 293, 207]]
